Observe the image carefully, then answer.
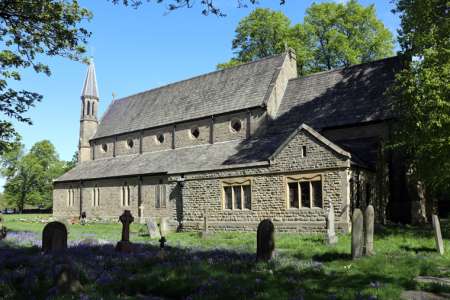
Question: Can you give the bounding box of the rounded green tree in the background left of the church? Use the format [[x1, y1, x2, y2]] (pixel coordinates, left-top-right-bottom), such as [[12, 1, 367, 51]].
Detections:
[[2, 140, 66, 211]]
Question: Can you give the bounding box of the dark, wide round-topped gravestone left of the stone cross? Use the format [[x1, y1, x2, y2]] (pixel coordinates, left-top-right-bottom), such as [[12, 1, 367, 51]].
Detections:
[[42, 221, 67, 253]]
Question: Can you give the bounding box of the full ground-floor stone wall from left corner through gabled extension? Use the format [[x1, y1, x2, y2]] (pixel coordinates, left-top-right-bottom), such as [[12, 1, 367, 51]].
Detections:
[[54, 127, 351, 233]]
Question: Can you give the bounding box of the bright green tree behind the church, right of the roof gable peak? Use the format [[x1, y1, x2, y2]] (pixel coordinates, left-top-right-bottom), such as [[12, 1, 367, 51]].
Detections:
[[304, 0, 394, 70]]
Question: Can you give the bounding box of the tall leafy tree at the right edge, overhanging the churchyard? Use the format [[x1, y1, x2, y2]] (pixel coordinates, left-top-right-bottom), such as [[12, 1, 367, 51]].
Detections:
[[392, 0, 450, 195]]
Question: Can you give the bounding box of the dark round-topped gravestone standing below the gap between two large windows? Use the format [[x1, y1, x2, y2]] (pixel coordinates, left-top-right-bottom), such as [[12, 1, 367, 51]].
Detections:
[[256, 219, 275, 261]]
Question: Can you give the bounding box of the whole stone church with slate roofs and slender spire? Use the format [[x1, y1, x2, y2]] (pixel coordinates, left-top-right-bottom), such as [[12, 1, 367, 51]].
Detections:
[[53, 50, 405, 233]]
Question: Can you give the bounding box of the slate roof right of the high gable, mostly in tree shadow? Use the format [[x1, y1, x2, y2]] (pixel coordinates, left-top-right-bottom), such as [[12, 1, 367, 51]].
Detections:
[[270, 56, 401, 134]]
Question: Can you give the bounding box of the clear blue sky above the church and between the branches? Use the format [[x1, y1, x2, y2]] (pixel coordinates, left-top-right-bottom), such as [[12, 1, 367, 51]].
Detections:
[[0, 0, 399, 187]]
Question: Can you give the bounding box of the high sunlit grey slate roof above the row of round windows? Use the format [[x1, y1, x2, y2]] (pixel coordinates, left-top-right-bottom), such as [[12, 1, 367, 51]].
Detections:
[[93, 54, 286, 139]]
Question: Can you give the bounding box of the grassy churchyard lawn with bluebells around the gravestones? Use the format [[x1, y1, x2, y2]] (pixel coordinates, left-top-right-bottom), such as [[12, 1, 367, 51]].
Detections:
[[0, 215, 450, 299]]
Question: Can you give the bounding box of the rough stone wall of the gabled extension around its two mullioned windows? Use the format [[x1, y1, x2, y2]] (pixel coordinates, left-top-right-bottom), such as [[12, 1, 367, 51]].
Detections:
[[182, 132, 350, 233]]
